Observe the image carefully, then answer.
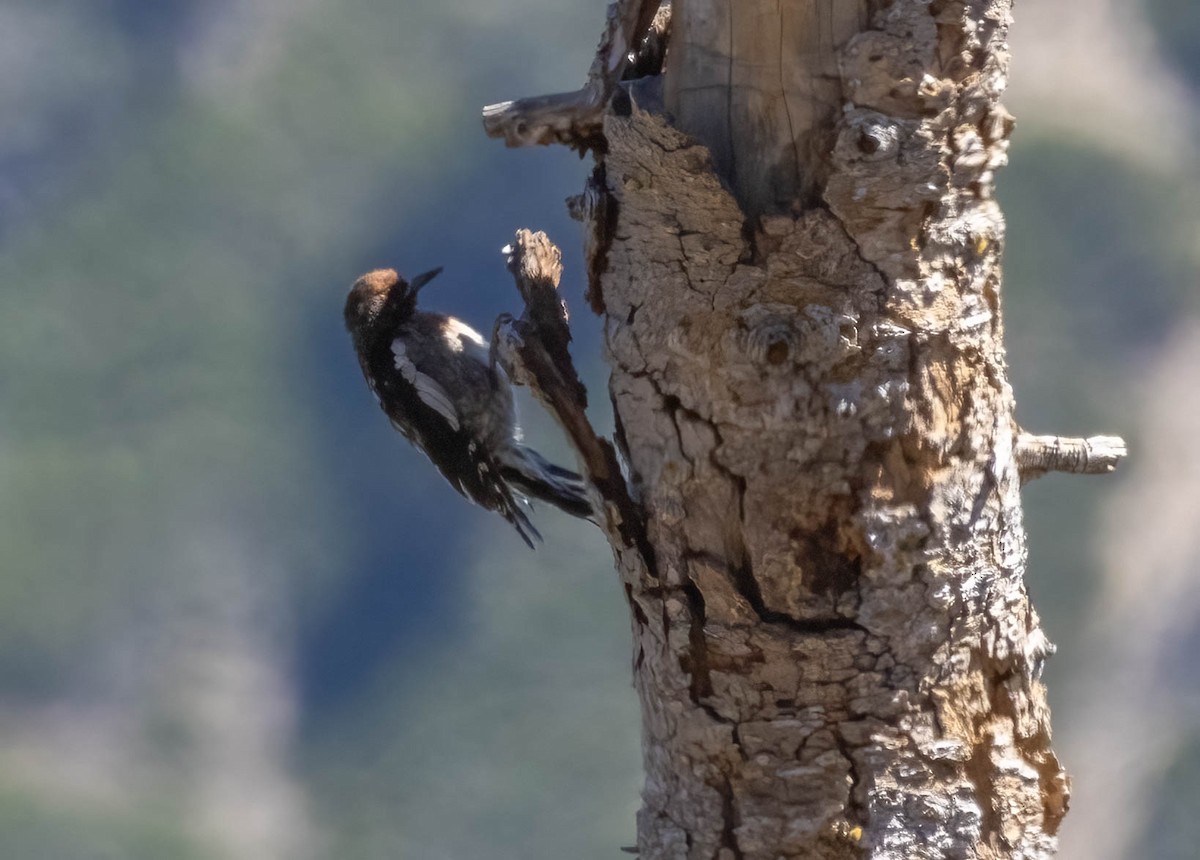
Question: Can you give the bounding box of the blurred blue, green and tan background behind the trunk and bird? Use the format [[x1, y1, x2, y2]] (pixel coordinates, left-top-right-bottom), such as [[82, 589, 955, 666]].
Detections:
[[0, 0, 1200, 860]]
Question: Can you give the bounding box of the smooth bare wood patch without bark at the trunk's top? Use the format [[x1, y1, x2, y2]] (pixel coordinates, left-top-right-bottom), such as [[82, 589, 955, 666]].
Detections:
[[666, 0, 869, 215]]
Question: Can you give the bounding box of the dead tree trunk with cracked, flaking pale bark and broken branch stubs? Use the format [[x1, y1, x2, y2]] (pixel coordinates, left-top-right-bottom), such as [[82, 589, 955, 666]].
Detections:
[[485, 0, 1122, 860]]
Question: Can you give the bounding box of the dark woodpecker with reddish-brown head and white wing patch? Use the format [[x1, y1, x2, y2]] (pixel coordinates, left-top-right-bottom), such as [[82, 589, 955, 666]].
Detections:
[[344, 267, 593, 548]]
